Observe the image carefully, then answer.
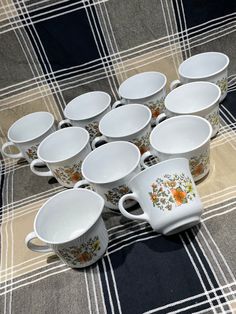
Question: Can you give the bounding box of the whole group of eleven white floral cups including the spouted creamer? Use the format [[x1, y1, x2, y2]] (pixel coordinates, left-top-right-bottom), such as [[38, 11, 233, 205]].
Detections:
[[2, 52, 229, 268]]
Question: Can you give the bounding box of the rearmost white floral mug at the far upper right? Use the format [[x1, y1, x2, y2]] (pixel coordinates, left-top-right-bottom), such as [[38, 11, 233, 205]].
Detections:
[[170, 52, 229, 101]]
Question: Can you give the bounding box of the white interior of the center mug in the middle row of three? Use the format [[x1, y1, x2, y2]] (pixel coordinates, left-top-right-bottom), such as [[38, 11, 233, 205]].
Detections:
[[99, 104, 152, 138]]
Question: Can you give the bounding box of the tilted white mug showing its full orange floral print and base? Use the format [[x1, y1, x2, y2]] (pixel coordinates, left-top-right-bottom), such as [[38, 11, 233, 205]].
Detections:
[[119, 158, 203, 235]]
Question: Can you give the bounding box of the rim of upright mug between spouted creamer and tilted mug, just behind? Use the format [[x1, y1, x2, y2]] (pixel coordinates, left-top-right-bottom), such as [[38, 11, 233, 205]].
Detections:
[[81, 141, 141, 185]]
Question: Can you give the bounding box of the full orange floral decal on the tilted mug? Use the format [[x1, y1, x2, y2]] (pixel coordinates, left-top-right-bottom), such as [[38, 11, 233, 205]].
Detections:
[[149, 173, 196, 211]]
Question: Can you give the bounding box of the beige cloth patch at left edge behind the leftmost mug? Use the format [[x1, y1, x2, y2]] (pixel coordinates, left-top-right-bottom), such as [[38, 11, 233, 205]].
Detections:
[[0, 84, 61, 144]]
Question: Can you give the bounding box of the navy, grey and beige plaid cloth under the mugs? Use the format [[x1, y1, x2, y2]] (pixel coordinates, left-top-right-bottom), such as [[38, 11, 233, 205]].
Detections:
[[0, 0, 236, 314]]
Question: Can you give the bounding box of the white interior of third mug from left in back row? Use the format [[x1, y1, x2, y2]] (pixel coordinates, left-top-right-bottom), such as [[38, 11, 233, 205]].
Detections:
[[119, 72, 166, 99]]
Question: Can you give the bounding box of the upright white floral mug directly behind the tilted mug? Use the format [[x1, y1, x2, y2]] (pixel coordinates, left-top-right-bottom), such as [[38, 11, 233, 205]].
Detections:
[[141, 115, 212, 181]]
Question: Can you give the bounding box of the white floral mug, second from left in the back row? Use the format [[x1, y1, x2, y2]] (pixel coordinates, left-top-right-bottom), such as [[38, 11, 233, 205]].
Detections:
[[58, 91, 111, 141]]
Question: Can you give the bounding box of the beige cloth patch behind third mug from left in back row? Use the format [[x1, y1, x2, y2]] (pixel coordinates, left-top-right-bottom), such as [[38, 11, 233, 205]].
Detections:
[[114, 44, 182, 90]]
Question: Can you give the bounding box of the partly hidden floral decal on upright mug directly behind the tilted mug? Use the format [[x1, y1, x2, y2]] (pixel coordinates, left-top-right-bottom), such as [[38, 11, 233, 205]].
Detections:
[[189, 149, 210, 178]]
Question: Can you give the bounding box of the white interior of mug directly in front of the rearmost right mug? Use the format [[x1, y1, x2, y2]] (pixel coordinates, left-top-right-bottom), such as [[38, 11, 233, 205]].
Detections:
[[165, 82, 221, 114]]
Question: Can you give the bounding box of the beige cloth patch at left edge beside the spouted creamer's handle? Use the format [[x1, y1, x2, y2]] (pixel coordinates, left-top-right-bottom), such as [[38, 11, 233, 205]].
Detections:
[[0, 199, 53, 282]]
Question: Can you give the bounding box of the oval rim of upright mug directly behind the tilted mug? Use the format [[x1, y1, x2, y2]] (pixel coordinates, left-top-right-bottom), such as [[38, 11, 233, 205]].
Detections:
[[150, 114, 213, 155]]
